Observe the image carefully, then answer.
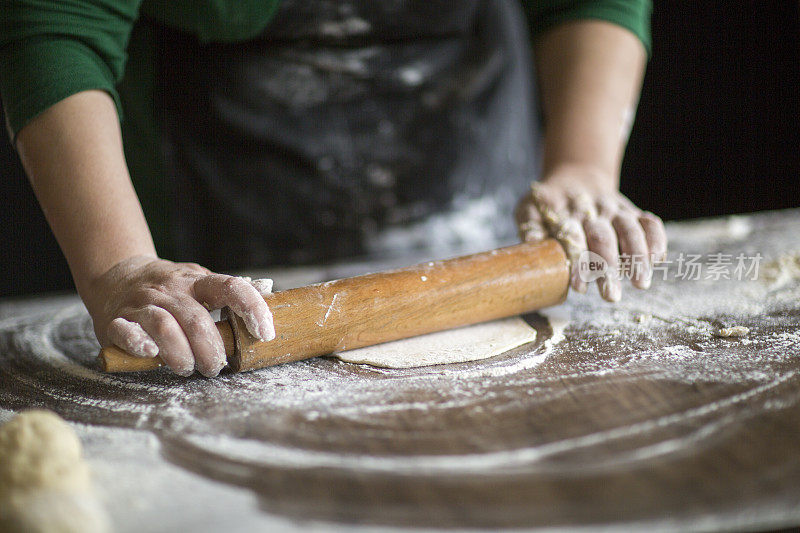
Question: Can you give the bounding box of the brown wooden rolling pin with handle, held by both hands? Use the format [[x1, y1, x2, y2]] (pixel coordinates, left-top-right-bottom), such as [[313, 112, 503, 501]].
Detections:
[[99, 239, 569, 372]]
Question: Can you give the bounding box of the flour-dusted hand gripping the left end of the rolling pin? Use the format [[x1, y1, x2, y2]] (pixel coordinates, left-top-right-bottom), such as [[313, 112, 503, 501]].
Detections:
[[84, 256, 275, 377]]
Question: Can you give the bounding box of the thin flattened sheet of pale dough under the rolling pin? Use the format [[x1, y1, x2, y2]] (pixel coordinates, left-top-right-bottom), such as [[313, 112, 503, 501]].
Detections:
[[335, 317, 536, 368]]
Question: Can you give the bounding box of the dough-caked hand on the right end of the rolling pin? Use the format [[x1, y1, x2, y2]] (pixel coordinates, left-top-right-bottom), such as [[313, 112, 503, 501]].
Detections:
[[516, 174, 667, 302]]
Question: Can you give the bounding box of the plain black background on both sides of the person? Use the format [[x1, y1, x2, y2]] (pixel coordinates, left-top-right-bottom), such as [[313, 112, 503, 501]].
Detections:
[[0, 0, 800, 296]]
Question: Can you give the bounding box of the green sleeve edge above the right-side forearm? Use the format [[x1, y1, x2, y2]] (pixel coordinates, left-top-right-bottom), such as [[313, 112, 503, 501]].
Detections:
[[522, 0, 653, 56]]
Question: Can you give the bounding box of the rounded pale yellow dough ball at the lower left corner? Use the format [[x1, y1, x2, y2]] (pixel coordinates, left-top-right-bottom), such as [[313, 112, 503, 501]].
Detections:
[[0, 410, 90, 498]]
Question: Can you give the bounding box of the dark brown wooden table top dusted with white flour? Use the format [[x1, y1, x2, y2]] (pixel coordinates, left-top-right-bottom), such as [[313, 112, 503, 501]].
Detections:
[[0, 210, 800, 531]]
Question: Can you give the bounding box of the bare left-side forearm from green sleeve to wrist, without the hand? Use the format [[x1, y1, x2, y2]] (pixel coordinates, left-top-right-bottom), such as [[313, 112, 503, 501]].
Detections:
[[17, 91, 156, 300]]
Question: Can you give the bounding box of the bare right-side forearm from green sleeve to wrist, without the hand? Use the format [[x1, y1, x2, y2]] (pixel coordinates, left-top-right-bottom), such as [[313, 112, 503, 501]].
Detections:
[[535, 20, 646, 188]]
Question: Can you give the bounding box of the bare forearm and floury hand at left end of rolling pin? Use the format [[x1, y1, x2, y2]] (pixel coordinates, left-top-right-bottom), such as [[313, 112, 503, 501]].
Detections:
[[11, 91, 275, 376]]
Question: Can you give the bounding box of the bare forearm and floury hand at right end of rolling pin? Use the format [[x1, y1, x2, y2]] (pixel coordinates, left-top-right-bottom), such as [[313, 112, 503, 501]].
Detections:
[[517, 20, 667, 302]]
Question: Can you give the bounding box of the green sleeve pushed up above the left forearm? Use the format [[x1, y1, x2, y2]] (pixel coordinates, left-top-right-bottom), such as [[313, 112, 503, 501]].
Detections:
[[0, 0, 141, 137]]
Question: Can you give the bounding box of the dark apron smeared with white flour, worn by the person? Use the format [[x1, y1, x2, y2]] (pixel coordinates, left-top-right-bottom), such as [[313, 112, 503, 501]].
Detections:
[[161, 0, 537, 269]]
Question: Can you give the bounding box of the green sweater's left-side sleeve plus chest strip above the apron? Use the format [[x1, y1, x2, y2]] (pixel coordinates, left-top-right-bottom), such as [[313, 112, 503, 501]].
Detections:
[[0, 0, 280, 137]]
